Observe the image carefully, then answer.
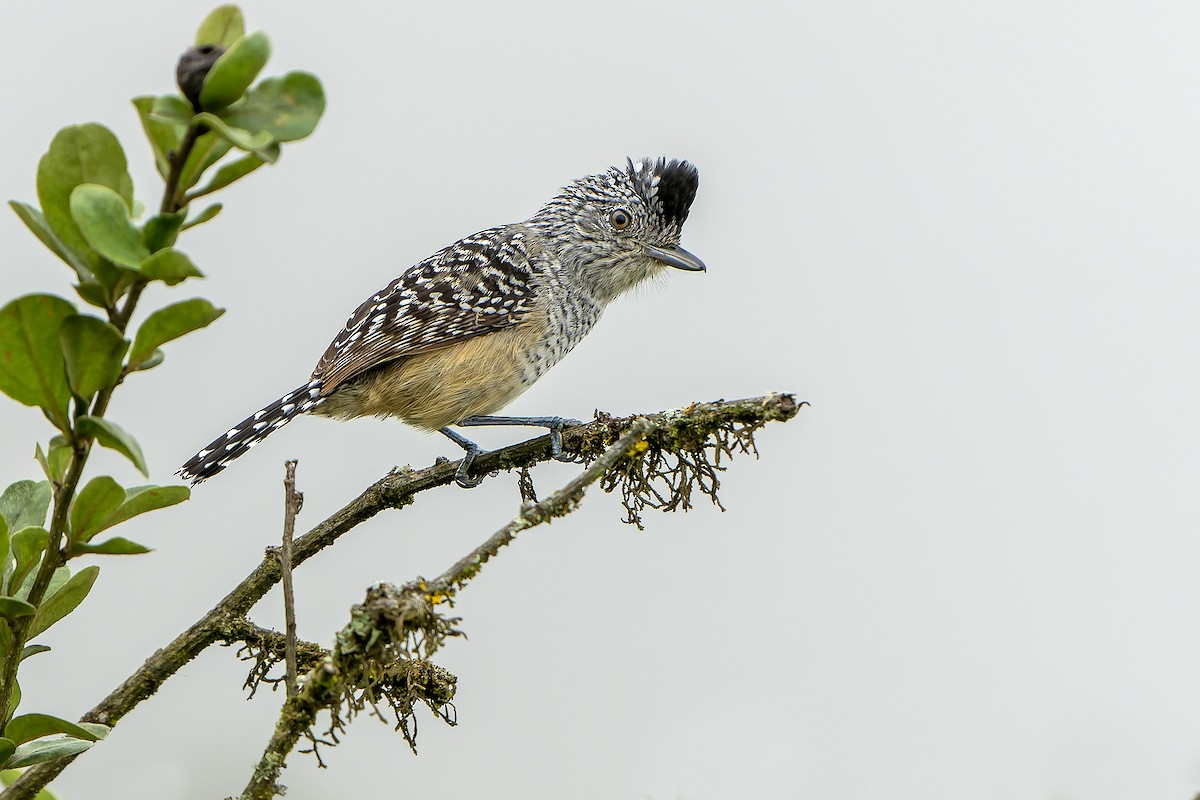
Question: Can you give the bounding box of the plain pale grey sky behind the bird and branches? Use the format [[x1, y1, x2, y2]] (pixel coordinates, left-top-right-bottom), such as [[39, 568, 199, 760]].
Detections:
[[0, 0, 1200, 800]]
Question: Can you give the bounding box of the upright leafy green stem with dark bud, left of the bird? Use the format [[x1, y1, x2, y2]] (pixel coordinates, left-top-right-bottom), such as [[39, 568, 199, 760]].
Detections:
[[0, 5, 325, 777]]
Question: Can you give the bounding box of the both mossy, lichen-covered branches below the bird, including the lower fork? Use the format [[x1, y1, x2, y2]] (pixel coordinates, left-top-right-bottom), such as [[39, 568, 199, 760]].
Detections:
[[7, 395, 803, 800]]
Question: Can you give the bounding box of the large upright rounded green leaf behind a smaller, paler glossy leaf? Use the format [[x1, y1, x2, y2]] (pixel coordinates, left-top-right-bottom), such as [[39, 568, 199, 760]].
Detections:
[[37, 122, 133, 272]]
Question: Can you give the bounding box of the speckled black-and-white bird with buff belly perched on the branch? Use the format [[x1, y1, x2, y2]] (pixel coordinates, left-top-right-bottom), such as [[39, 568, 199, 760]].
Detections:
[[176, 157, 706, 488]]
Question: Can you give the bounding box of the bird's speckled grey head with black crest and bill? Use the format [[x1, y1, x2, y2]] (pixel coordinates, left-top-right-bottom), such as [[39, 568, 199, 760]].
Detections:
[[529, 158, 704, 300]]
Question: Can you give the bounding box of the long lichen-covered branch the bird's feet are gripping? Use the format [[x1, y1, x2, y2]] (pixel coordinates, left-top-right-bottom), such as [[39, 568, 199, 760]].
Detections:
[[7, 395, 800, 800]]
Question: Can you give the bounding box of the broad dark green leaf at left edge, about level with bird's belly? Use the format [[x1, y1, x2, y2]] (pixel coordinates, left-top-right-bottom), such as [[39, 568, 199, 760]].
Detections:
[[0, 294, 76, 431]]
